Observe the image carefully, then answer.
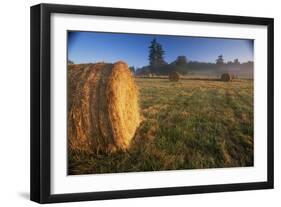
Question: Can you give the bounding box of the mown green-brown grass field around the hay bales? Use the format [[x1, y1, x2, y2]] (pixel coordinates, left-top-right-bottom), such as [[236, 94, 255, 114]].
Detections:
[[68, 78, 254, 174]]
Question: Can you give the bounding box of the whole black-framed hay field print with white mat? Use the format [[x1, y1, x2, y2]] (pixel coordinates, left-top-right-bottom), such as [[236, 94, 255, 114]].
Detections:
[[31, 4, 273, 203]]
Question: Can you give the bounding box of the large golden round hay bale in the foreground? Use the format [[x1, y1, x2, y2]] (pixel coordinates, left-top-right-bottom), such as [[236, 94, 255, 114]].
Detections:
[[67, 62, 140, 153]]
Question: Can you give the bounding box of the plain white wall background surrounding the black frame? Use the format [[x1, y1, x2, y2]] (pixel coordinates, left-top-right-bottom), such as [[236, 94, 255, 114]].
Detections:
[[0, 0, 281, 207]]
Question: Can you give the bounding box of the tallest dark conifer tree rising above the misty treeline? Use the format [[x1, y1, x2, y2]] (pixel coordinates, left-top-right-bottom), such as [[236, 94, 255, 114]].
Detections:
[[148, 38, 166, 71]]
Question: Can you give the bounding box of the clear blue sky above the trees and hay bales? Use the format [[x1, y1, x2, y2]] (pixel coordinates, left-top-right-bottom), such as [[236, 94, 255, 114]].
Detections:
[[68, 31, 254, 67]]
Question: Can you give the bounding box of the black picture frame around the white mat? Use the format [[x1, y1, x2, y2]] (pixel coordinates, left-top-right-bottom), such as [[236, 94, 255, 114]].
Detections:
[[30, 4, 274, 203]]
